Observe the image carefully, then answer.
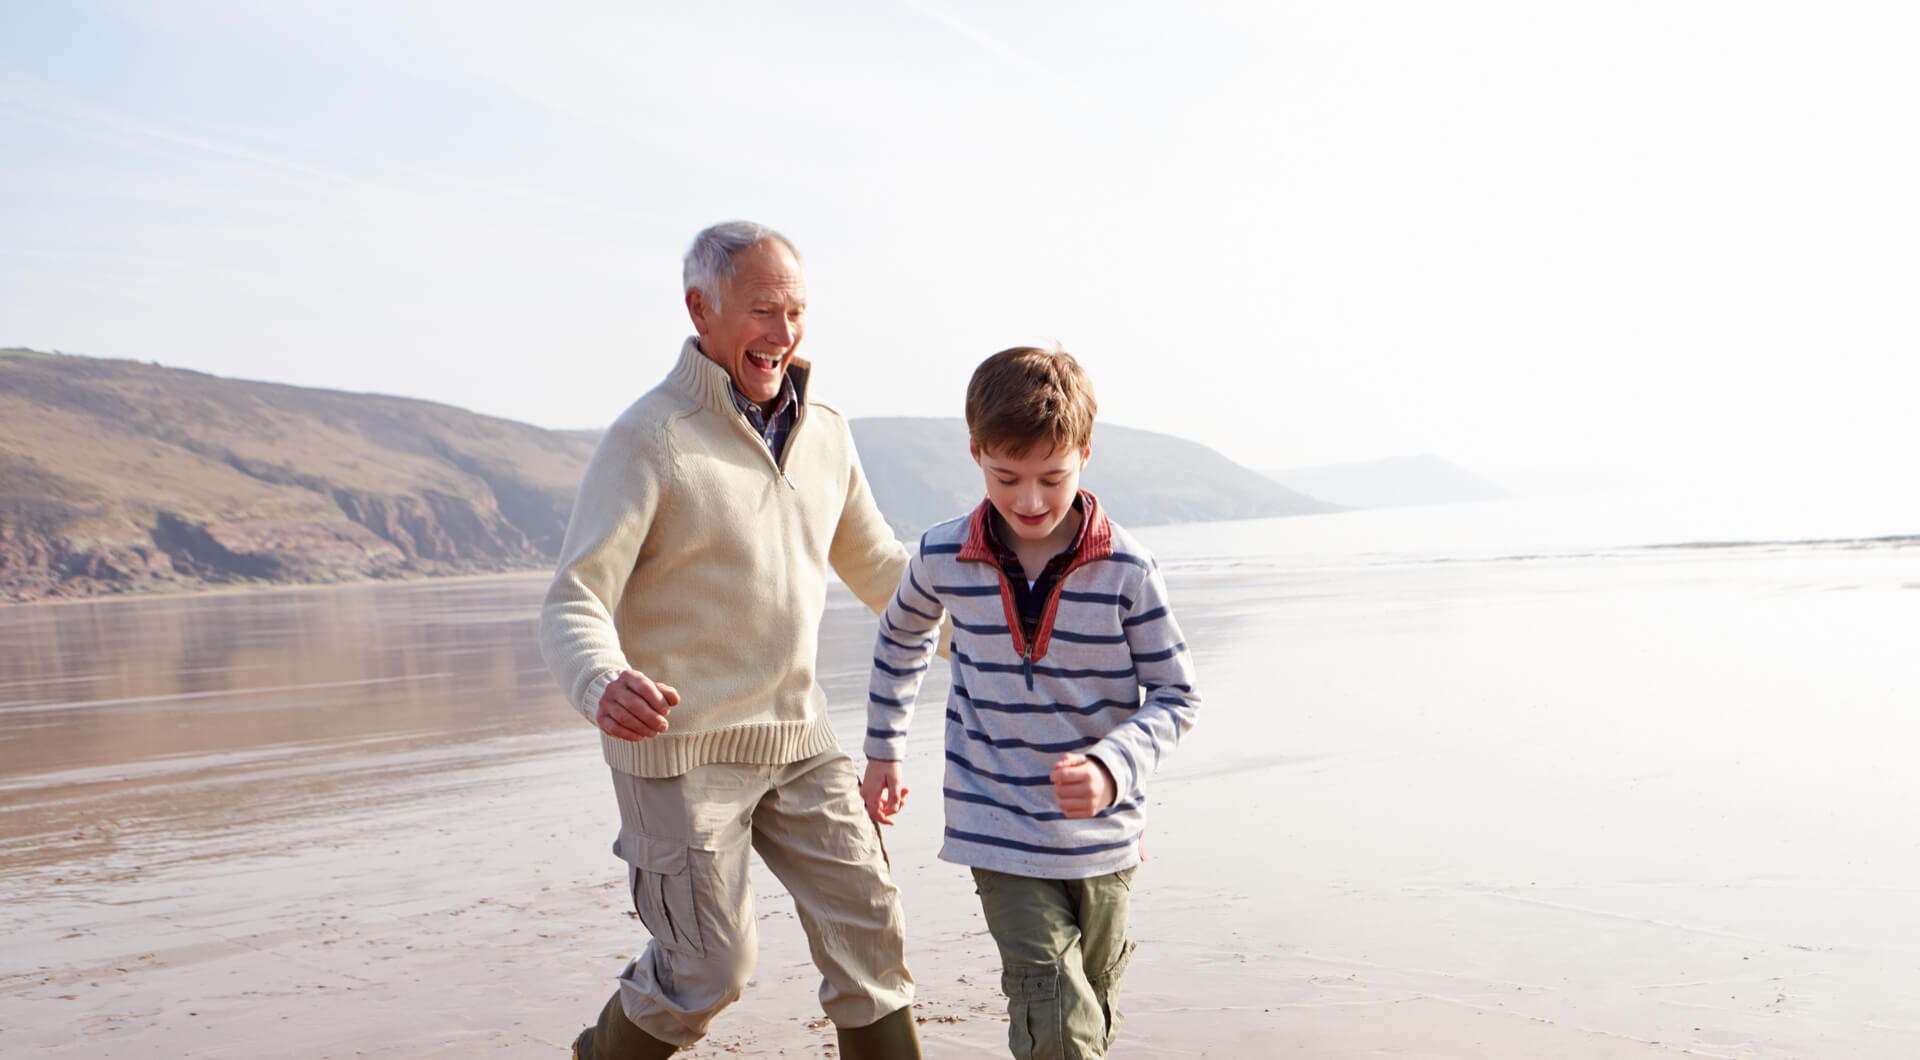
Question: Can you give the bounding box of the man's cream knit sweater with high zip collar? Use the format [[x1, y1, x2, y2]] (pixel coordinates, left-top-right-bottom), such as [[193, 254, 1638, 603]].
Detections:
[[540, 338, 906, 778]]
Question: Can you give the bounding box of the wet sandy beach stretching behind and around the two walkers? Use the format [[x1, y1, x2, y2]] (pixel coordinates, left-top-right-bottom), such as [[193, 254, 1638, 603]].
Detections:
[[0, 533, 1920, 1060]]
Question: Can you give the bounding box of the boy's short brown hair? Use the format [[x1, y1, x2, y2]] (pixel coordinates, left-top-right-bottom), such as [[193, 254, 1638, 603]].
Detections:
[[966, 346, 1098, 457]]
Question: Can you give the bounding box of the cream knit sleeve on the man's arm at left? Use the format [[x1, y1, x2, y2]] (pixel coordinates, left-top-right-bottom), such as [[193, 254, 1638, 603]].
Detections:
[[540, 422, 660, 722]]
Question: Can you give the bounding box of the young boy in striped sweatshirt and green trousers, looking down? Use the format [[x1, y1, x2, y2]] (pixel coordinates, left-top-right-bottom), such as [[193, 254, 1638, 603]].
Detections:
[[860, 346, 1198, 1060]]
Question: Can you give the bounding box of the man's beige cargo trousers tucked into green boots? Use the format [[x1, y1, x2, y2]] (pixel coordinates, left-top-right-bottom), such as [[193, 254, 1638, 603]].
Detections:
[[612, 749, 914, 1047]]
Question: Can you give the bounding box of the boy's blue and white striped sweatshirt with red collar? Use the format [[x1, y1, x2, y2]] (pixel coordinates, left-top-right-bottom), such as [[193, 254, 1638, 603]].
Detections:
[[866, 490, 1200, 879]]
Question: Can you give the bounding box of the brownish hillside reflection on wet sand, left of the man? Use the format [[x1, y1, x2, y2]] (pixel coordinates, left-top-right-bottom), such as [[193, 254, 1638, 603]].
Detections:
[[0, 578, 574, 879]]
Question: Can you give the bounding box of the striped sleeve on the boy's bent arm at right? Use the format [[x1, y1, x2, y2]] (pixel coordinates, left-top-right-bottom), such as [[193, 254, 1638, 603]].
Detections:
[[1087, 559, 1200, 803]]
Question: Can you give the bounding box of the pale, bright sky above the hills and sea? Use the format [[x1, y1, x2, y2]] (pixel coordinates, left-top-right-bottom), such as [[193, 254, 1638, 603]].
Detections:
[[0, 0, 1920, 488]]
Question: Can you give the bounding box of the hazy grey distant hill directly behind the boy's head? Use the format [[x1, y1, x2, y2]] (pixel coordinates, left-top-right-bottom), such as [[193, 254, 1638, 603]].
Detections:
[[852, 417, 1338, 538]]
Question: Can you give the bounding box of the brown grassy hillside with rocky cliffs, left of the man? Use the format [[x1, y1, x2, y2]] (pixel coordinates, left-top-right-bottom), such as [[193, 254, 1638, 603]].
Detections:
[[0, 351, 593, 601]]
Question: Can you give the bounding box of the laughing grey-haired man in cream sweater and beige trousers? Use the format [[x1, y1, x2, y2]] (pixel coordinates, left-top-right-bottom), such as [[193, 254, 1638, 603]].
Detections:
[[540, 221, 920, 1060]]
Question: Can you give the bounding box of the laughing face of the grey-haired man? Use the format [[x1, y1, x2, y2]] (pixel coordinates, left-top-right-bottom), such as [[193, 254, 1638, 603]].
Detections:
[[687, 240, 806, 405]]
